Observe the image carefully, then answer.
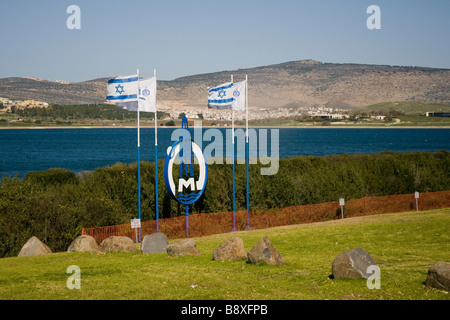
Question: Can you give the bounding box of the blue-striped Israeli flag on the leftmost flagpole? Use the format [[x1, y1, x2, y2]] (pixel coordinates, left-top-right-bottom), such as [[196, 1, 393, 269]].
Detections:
[[106, 75, 138, 102]]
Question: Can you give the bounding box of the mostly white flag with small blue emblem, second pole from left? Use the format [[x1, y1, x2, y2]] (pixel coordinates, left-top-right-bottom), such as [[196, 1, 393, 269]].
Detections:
[[116, 77, 156, 112]]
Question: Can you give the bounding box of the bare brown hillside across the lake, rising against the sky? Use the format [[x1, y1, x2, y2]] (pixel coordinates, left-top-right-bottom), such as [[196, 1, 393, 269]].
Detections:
[[0, 60, 450, 109]]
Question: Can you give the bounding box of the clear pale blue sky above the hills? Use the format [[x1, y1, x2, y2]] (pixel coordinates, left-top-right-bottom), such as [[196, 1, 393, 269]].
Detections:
[[0, 0, 450, 82]]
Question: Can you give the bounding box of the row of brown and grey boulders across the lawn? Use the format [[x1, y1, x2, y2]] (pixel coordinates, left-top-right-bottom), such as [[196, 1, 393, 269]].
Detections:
[[15, 233, 450, 291]]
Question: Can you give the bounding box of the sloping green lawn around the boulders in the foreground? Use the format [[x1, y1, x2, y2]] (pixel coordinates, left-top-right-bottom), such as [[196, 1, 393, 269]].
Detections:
[[0, 209, 450, 300]]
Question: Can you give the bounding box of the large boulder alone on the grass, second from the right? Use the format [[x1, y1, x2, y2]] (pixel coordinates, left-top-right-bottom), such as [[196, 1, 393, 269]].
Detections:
[[332, 248, 376, 279]]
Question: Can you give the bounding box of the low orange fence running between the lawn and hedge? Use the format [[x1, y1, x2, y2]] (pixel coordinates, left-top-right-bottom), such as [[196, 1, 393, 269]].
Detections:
[[82, 191, 450, 243]]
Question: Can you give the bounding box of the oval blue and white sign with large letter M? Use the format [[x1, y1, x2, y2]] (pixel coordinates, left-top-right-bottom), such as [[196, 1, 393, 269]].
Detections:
[[164, 118, 208, 205]]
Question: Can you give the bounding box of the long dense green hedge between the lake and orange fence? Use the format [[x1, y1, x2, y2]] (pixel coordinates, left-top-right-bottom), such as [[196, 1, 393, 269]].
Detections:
[[0, 151, 450, 257]]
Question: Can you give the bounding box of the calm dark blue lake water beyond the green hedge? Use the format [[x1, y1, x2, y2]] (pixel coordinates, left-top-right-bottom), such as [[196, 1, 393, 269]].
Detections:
[[0, 128, 450, 177]]
